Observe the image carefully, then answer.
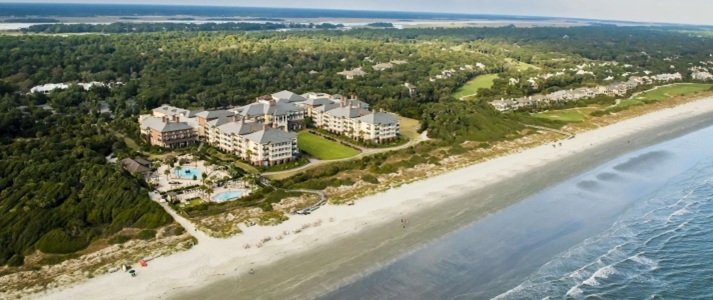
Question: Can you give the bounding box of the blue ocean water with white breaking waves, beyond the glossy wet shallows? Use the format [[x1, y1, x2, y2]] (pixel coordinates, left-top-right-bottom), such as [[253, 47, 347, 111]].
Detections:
[[496, 161, 713, 299]]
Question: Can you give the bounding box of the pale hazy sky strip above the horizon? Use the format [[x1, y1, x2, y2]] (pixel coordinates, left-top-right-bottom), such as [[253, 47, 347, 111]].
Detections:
[[0, 0, 713, 25]]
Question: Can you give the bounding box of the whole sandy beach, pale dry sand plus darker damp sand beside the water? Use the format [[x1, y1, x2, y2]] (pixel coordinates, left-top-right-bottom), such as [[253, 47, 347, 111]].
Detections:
[[36, 98, 713, 299]]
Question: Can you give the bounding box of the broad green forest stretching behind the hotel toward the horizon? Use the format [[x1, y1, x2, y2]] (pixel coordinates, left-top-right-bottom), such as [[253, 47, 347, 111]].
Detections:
[[0, 24, 713, 137]]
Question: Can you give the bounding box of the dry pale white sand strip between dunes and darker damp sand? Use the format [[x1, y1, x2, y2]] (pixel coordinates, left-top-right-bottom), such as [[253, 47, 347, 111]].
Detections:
[[38, 98, 713, 300]]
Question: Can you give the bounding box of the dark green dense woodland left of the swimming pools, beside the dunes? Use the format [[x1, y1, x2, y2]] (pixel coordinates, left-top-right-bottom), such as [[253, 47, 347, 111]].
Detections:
[[0, 85, 172, 266]]
